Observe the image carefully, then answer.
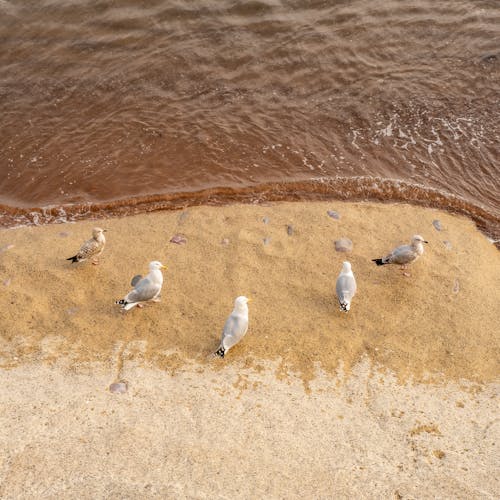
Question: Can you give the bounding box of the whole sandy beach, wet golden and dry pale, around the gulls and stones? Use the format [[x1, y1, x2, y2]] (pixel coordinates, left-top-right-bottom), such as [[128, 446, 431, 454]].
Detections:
[[0, 202, 500, 498]]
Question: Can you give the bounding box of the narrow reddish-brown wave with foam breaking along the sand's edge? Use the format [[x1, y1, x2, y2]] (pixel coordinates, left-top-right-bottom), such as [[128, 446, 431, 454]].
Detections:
[[0, 177, 500, 247]]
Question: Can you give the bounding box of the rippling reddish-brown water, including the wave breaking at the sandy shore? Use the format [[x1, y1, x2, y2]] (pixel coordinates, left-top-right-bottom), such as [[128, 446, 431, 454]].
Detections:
[[0, 0, 500, 238]]
